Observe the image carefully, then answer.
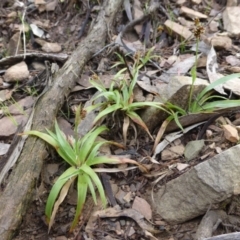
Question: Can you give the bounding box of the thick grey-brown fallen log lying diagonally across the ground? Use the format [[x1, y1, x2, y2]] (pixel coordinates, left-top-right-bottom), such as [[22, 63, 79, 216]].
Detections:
[[0, 0, 123, 240]]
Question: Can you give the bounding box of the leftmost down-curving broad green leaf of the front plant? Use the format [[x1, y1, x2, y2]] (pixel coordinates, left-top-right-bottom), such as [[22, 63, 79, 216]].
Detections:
[[45, 167, 79, 219]]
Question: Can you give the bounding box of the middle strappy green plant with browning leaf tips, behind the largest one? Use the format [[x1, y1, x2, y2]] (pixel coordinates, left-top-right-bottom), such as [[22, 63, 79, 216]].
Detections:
[[86, 55, 167, 145]]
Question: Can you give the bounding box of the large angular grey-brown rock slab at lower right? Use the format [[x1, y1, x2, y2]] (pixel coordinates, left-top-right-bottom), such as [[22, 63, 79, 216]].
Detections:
[[153, 145, 240, 224]]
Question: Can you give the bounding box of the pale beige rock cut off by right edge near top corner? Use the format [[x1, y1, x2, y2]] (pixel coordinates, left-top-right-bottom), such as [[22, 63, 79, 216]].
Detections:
[[223, 6, 240, 37]]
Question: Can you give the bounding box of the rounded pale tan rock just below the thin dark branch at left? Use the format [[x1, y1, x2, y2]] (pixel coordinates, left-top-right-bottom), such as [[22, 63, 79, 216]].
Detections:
[[3, 61, 29, 82]]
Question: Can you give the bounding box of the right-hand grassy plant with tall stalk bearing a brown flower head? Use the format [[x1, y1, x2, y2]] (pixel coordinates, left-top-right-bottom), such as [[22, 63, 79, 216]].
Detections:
[[153, 19, 240, 150]]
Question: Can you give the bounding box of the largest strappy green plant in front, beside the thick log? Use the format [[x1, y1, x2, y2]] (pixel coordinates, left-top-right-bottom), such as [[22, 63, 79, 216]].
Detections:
[[23, 122, 144, 231]]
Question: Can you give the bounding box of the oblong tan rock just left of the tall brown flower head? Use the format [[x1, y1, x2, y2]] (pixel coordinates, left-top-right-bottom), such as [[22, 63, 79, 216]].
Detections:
[[164, 20, 193, 40]]
